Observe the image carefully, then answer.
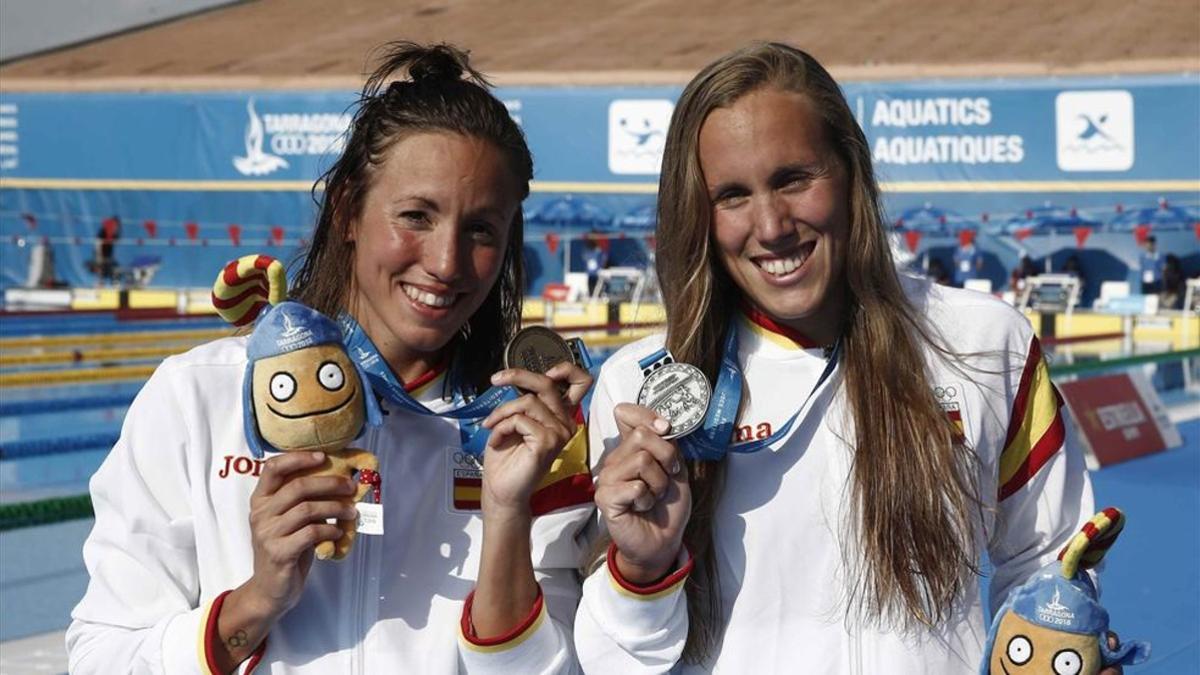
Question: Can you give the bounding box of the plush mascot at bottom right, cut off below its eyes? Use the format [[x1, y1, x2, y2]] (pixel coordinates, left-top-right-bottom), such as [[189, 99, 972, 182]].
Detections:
[[980, 508, 1150, 675]]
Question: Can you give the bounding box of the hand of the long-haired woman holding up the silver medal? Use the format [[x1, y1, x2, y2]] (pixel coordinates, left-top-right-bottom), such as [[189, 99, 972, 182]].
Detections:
[[595, 404, 691, 585]]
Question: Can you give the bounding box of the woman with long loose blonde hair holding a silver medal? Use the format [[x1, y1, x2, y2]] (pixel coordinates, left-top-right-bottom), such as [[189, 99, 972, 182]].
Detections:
[[576, 43, 1092, 674]]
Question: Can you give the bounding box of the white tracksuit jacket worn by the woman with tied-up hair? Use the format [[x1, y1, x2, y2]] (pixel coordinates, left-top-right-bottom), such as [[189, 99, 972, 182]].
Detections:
[[67, 338, 592, 675]]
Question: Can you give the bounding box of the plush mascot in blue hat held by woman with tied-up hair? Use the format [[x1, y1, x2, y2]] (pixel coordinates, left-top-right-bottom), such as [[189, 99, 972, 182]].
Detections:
[[212, 256, 380, 560]]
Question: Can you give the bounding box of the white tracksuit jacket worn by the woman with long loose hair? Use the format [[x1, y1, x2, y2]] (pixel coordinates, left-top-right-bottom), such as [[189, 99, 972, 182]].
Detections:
[[575, 279, 1093, 675]]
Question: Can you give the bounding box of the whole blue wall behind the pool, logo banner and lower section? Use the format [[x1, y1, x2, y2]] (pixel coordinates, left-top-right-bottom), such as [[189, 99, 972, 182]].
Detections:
[[0, 73, 1200, 292]]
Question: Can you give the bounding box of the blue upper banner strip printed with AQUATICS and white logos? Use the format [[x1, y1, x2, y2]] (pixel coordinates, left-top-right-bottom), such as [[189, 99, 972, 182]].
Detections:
[[0, 73, 1200, 186]]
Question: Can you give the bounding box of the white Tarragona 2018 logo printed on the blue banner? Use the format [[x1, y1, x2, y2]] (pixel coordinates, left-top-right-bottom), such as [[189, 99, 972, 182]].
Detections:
[[233, 98, 350, 177]]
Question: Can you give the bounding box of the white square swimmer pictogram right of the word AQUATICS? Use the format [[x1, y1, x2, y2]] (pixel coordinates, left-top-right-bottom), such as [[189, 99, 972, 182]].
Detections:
[[1055, 90, 1134, 171]]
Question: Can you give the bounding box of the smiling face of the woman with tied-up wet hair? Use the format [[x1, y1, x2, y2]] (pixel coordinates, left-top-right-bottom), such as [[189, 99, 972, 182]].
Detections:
[[350, 132, 521, 377]]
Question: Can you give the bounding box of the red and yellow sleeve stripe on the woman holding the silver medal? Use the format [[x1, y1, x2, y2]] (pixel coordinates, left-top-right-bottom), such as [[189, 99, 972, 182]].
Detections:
[[998, 338, 1066, 500]]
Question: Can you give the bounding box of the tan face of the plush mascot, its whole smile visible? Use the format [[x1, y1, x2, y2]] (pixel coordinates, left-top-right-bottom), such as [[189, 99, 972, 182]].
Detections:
[[251, 345, 366, 450]]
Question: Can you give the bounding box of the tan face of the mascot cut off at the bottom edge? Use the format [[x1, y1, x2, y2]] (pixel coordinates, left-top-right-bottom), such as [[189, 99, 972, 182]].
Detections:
[[988, 611, 1100, 675]]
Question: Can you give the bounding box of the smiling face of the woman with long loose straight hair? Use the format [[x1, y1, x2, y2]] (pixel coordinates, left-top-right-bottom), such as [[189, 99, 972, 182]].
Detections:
[[700, 88, 850, 344]]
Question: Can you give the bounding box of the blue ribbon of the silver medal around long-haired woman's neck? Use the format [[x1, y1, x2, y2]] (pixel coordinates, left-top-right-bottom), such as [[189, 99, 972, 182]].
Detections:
[[637, 325, 841, 461]]
